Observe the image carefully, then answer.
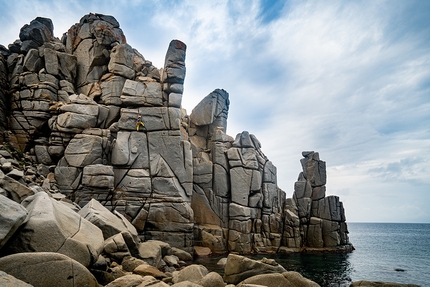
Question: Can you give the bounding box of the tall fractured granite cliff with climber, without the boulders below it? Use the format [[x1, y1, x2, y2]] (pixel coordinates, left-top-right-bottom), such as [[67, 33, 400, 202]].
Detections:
[[0, 14, 353, 256]]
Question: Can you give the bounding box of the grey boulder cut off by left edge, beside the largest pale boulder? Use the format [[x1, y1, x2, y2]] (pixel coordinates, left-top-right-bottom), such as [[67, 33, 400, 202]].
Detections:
[[0, 195, 27, 249]]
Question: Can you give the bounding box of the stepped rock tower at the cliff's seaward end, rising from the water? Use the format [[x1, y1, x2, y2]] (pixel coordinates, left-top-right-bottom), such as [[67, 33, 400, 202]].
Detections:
[[283, 151, 353, 252]]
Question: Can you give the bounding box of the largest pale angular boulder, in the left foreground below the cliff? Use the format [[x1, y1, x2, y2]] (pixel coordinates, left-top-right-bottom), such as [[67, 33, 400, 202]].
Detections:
[[5, 192, 104, 267]]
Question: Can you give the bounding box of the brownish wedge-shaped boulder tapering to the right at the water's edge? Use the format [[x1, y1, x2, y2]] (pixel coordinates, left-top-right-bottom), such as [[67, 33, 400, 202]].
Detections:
[[223, 253, 286, 284]]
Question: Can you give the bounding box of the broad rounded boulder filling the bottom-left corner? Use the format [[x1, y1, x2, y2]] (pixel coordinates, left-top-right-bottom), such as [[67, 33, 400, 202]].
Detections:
[[0, 252, 99, 287]]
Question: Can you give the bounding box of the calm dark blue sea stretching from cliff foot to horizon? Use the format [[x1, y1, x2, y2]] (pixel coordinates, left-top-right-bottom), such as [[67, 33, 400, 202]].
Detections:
[[196, 222, 430, 287]]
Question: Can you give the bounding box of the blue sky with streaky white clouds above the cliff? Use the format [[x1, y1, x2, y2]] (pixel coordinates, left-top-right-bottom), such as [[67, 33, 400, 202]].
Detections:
[[0, 0, 430, 223]]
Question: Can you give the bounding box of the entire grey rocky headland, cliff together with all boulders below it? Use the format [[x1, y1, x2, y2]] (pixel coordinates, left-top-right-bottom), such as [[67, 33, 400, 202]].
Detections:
[[0, 13, 414, 287]]
